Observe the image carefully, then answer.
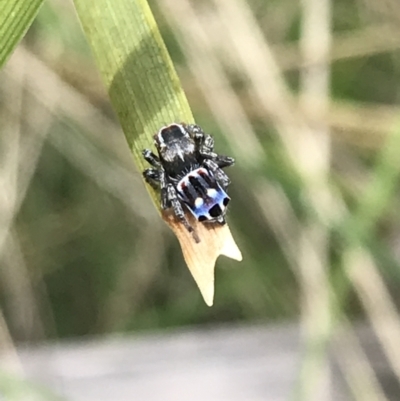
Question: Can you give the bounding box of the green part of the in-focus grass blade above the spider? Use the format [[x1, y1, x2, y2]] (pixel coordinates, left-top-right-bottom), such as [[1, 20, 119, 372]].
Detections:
[[74, 0, 193, 183]]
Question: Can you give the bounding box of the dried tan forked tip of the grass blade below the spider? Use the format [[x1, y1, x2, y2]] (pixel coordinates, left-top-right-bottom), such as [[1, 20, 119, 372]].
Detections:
[[162, 212, 242, 306]]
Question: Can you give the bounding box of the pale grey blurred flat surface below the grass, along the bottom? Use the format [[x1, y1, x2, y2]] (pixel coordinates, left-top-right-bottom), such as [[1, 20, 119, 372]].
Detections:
[[0, 325, 360, 401]]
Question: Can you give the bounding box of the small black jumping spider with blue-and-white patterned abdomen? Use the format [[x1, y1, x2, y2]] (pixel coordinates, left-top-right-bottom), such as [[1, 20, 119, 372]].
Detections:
[[143, 123, 234, 239]]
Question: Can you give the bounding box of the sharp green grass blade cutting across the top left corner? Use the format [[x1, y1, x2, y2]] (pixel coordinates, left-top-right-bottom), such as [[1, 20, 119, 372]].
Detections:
[[0, 0, 43, 68]]
